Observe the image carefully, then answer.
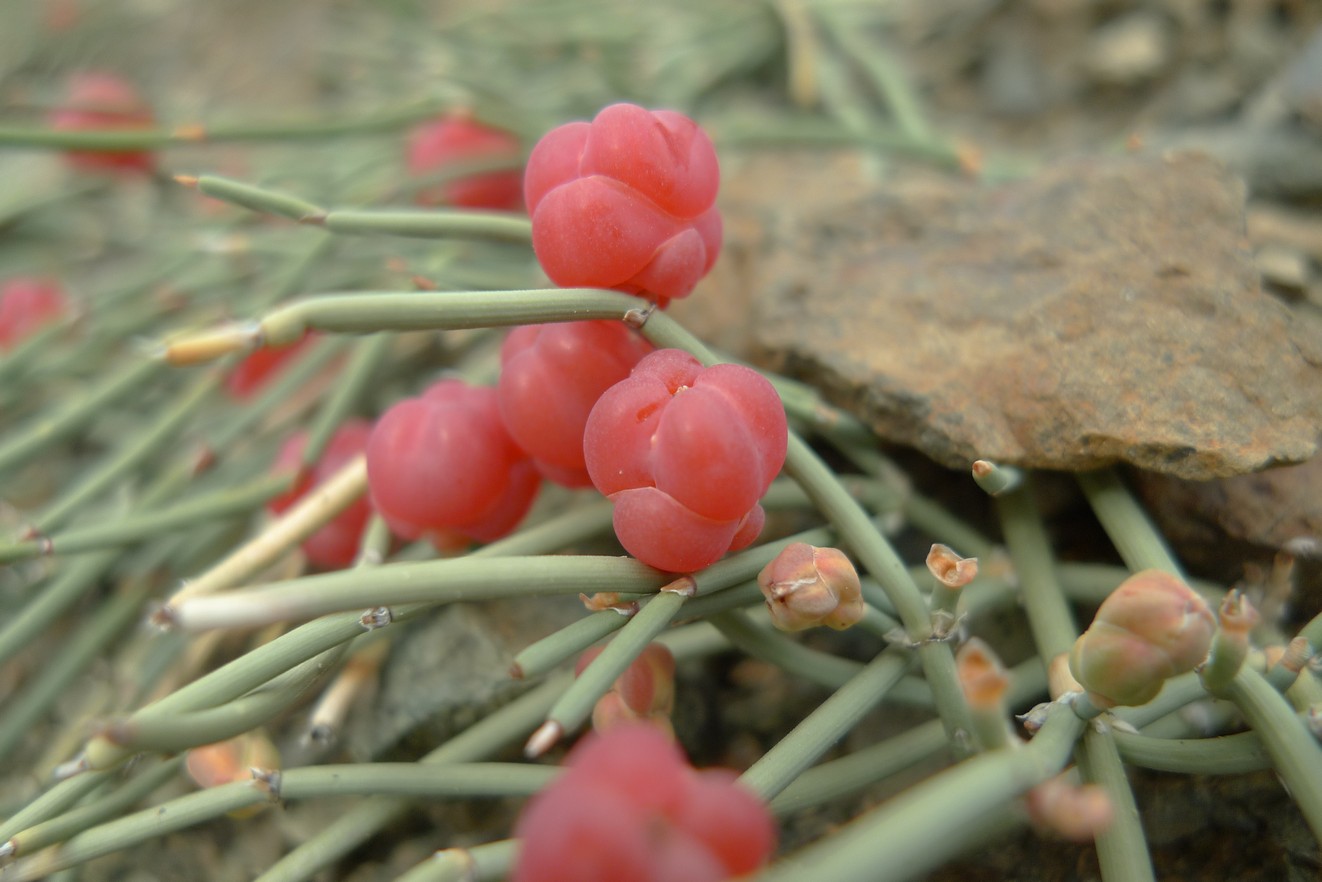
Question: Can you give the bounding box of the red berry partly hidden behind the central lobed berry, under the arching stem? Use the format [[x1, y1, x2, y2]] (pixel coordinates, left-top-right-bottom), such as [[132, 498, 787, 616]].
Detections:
[[497, 321, 652, 487]]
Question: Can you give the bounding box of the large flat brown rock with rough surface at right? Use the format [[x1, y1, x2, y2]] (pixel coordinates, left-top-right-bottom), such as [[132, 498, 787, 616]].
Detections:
[[744, 155, 1322, 480]]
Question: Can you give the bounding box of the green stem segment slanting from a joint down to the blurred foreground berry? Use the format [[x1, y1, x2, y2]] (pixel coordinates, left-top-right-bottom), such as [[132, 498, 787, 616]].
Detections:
[[739, 649, 914, 803]]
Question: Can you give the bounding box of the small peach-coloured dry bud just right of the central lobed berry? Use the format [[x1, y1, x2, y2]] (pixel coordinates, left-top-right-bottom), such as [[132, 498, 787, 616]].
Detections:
[[758, 542, 863, 631]]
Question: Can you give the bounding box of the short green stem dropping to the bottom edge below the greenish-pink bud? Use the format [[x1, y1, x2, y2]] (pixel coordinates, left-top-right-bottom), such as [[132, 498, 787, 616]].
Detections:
[[1075, 726, 1155, 882]]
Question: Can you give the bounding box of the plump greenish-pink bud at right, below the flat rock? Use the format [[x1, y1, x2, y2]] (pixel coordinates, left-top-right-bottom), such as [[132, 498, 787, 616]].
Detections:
[[1069, 570, 1216, 707]]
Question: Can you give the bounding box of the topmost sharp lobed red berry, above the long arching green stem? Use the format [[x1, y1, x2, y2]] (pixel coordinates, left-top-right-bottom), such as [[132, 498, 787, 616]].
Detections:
[[524, 104, 722, 307]]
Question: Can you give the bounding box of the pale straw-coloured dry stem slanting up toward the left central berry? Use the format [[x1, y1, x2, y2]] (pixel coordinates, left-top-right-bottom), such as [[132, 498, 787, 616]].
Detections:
[[168, 456, 368, 607]]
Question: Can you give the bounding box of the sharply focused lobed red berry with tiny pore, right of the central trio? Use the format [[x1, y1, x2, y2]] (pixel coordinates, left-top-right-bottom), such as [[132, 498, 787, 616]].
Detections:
[[583, 349, 788, 573]]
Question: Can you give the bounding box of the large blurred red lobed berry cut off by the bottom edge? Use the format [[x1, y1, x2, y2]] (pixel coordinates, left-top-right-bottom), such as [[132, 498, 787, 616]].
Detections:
[[512, 725, 776, 882]]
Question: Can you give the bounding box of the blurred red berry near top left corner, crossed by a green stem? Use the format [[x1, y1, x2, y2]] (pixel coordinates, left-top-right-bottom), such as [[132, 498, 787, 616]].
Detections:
[[50, 73, 156, 173]]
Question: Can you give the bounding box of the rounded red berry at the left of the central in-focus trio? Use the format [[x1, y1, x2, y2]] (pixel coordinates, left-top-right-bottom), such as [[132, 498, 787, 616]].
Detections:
[[368, 380, 541, 547]]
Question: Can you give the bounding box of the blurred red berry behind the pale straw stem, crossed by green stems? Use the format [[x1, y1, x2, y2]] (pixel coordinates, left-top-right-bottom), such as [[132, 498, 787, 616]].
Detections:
[[267, 419, 371, 569]]
